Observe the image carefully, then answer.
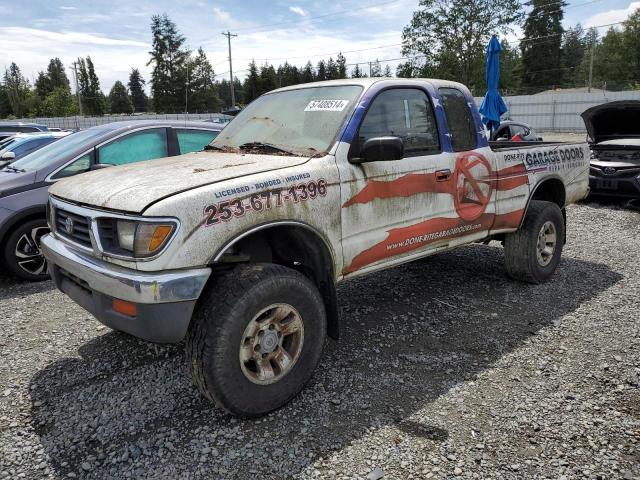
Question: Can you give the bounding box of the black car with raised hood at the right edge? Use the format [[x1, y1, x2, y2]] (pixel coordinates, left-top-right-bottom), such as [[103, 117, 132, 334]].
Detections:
[[582, 100, 640, 199]]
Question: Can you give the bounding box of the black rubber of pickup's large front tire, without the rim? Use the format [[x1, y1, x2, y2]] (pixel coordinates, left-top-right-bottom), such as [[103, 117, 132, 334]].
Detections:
[[186, 264, 326, 417]]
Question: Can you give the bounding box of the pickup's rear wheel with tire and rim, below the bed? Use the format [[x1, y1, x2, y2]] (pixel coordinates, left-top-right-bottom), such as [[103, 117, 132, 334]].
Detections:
[[504, 200, 565, 284]]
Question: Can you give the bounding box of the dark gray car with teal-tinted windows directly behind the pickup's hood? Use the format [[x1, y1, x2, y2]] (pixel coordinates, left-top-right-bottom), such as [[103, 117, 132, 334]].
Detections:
[[0, 120, 223, 280]]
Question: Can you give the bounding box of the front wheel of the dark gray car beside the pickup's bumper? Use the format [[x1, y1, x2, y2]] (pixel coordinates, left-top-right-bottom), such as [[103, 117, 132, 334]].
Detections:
[[4, 219, 49, 281]]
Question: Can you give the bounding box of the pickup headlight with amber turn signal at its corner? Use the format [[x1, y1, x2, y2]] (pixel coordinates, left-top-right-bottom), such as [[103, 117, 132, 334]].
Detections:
[[114, 220, 176, 258]]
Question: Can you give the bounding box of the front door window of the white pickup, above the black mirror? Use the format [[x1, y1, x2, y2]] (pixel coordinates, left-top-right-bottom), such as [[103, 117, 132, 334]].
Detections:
[[358, 88, 440, 156]]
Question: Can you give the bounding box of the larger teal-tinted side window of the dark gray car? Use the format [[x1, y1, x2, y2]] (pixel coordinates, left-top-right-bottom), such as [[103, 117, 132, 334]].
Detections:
[[98, 128, 169, 165]]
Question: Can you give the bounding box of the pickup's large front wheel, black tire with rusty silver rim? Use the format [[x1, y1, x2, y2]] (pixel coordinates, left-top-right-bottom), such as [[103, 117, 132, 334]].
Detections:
[[186, 264, 326, 417]]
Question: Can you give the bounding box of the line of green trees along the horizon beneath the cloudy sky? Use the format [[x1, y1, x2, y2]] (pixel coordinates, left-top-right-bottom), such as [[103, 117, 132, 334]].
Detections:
[[0, 5, 640, 118]]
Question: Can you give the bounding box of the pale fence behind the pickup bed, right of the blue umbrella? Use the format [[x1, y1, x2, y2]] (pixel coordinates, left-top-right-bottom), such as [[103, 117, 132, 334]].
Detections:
[[475, 90, 640, 133]]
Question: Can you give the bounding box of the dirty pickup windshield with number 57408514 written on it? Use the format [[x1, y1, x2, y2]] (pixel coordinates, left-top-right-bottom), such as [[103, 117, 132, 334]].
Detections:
[[210, 85, 362, 156]]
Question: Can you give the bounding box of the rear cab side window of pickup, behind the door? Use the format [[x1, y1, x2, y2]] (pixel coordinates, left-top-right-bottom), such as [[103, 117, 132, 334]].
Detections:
[[438, 88, 478, 152]]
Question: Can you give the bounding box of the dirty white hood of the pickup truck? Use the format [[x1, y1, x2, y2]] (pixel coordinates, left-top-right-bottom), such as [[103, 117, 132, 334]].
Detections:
[[49, 151, 309, 213]]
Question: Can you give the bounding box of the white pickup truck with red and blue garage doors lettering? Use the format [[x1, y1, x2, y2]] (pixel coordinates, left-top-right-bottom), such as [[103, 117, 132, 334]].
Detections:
[[42, 78, 589, 416]]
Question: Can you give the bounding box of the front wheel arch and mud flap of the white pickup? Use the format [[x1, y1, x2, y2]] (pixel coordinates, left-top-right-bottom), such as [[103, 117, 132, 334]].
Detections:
[[209, 221, 339, 340]]
